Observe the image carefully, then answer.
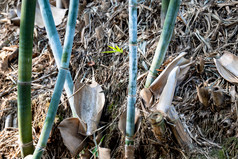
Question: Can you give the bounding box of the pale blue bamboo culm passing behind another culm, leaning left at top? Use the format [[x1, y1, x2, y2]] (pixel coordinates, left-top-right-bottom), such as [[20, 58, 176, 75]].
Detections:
[[38, 0, 77, 117]]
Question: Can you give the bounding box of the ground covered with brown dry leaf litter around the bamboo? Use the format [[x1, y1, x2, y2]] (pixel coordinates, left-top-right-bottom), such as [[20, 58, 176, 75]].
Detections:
[[0, 0, 238, 159]]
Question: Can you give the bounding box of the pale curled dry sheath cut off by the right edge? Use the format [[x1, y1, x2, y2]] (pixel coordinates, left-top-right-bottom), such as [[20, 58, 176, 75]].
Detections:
[[214, 51, 238, 85]]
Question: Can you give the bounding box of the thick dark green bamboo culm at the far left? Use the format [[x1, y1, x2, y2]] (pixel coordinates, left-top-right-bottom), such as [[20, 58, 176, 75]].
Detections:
[[17, 0, 36, 157]]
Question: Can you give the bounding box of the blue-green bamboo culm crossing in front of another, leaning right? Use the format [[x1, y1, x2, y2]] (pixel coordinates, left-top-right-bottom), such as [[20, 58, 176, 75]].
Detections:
[[33, 0, 79, 159]]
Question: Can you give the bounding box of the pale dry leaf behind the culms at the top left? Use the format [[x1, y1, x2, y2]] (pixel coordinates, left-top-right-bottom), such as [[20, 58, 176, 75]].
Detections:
[[17, 2, 67, 28]]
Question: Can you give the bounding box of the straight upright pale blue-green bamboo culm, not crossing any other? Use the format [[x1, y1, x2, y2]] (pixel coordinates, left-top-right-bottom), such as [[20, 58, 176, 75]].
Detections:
[[125, 0, 137, 145]]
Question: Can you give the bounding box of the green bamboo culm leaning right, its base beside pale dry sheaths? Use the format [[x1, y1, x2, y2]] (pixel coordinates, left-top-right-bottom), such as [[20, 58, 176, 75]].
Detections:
[[145, 0, 180, 88]]
